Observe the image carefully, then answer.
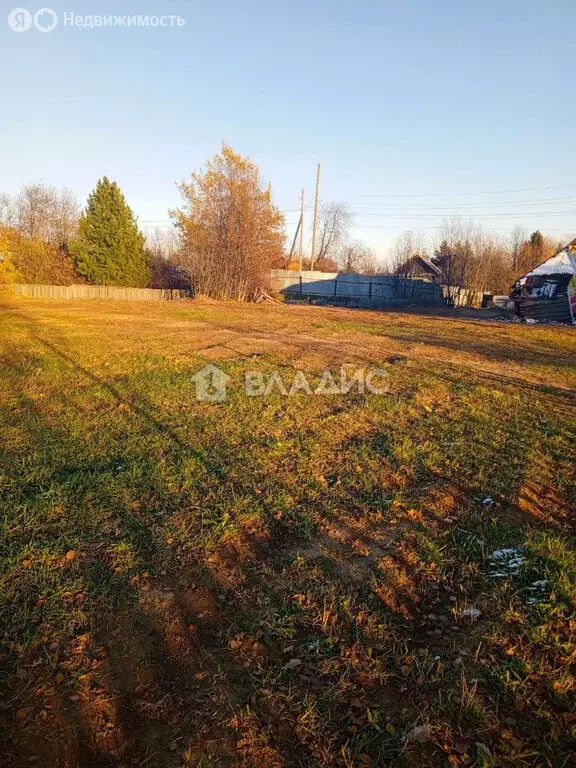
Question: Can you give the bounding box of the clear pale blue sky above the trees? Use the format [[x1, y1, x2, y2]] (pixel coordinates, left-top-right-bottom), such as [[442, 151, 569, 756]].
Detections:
[[0, 0, 576, 255]]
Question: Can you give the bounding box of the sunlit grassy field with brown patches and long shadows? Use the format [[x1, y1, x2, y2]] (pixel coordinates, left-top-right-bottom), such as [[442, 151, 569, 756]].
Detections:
[[0, 298, 576, 768]]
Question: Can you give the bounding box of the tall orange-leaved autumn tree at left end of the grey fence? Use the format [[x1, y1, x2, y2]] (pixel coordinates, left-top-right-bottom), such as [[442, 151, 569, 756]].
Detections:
[[171, 144, 286, 301]]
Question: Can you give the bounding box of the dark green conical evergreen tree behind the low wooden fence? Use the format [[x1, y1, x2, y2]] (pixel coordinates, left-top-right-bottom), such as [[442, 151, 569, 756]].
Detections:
[[70, 176, 149, 288]]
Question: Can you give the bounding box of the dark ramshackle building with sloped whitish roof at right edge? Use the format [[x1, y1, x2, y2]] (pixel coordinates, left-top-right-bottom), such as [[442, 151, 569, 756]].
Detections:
[[510, 239, 576, 323]]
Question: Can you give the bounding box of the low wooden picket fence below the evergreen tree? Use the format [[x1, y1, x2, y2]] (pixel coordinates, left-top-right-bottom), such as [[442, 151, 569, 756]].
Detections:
[[11, 284, 190, 301]]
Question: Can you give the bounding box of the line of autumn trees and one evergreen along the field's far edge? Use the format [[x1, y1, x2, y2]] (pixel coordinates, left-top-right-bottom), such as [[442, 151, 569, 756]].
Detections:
[[0, 144, 561, 300]]
